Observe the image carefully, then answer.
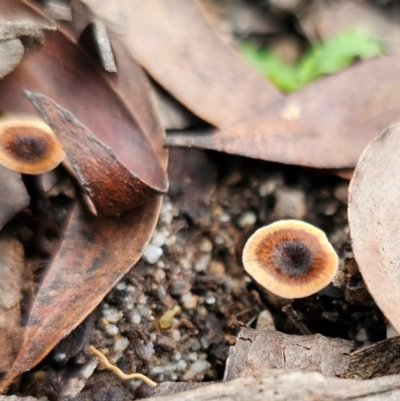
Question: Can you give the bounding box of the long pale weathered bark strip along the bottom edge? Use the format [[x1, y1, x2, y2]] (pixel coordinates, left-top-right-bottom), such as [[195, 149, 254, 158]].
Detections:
[[143, 370, 400, 401]]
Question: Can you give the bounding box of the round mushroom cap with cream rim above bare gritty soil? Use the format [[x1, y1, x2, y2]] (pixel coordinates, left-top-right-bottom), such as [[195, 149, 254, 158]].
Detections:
[[243, 220, 339, 299]]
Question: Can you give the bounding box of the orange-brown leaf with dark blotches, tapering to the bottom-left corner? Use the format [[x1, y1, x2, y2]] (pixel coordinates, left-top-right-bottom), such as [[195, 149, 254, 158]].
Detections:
[[0, 198, 161, 391]]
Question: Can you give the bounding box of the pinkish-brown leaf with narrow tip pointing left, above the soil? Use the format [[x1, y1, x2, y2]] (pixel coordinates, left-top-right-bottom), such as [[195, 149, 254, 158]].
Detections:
[[167, 57, 400, 168]]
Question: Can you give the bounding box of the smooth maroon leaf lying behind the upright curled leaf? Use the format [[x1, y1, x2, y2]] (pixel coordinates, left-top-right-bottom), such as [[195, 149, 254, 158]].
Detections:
[[0, 0, 168, 214]]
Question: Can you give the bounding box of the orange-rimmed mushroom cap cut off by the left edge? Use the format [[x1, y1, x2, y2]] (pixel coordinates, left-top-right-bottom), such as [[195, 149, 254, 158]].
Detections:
[[0, 116, 65, 175]]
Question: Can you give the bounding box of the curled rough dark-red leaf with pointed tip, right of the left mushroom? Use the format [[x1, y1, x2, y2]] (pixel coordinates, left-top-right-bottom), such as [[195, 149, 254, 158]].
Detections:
[[27, 92, 162, 217]]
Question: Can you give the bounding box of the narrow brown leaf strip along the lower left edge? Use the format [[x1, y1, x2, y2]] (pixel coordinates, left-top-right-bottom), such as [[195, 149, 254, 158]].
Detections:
[[0, 230, 25, 376]]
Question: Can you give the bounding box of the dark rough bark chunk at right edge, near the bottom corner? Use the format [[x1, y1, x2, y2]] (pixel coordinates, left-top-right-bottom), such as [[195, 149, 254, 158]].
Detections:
[[340, 336, 400, 380]]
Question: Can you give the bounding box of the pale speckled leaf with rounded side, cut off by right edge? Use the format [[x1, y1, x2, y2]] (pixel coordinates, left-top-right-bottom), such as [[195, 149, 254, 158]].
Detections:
[[348, 125, 400, 331]]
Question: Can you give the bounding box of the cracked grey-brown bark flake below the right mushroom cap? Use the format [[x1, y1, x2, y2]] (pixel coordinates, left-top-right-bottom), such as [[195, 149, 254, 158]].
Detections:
[[224, 328, 354, 380]]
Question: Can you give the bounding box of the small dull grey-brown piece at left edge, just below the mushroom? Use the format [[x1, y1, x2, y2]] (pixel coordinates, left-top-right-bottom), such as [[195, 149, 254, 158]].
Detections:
[[0, 165, 29, 229]]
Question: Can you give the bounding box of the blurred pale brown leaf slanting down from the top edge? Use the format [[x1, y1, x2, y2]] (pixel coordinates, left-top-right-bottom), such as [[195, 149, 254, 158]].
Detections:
[[73, 0, 281, 127]]
